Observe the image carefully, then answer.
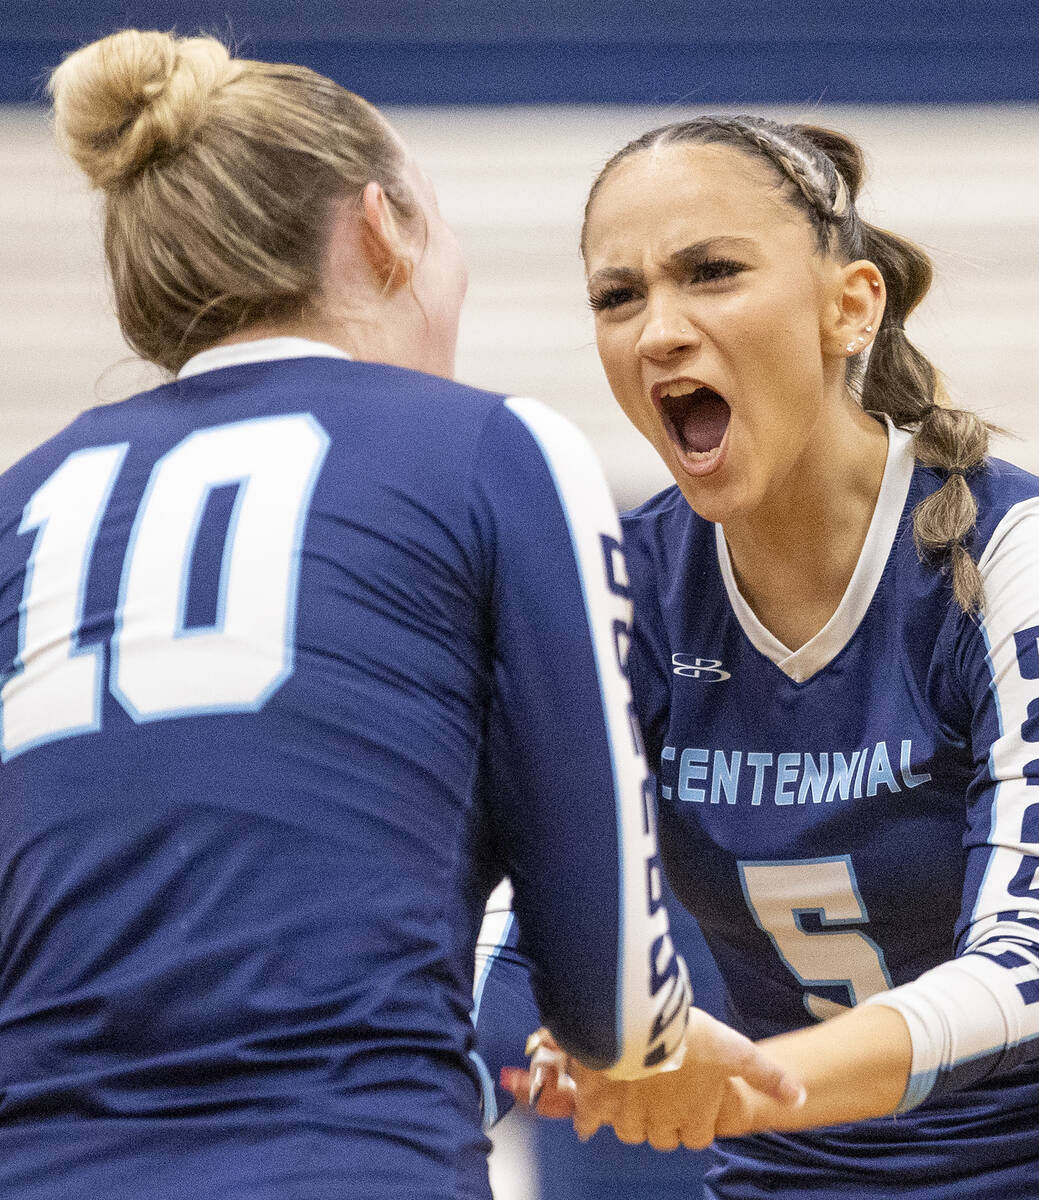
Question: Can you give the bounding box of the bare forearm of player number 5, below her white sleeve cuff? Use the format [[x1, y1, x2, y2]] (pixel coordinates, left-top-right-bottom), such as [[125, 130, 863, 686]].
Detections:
[[717, 1004, 912, 1138]]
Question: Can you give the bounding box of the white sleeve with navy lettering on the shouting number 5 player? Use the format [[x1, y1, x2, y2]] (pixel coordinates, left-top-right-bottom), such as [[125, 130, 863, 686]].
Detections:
[[867, 499, 1039, 1111]]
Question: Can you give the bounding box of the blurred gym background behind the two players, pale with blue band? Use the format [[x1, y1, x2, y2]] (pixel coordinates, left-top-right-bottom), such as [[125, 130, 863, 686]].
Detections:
[[0, 0, 1039, 1200]]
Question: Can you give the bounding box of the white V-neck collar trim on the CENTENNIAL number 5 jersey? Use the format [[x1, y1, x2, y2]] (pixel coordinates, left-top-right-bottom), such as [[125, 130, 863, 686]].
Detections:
[[714, 421, 915, 683]]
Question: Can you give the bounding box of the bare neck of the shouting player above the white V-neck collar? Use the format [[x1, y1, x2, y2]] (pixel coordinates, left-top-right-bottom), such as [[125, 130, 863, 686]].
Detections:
[[723, 406, 888, 650]]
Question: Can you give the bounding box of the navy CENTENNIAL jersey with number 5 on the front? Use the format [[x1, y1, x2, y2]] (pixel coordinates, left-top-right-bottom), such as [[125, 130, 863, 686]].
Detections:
[[624, 430, 1039, 1200]]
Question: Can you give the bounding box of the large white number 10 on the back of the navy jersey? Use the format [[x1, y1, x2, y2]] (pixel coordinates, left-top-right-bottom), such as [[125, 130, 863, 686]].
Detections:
[[0, 414, 329, 762]]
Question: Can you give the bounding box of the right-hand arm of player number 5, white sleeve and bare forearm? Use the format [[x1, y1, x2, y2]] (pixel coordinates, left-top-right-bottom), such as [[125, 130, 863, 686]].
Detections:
[[728, 500, 1039, 1130]]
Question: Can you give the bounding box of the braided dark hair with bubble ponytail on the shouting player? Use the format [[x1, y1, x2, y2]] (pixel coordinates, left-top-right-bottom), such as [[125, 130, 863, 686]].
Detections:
[[581, 116, 996, 613]]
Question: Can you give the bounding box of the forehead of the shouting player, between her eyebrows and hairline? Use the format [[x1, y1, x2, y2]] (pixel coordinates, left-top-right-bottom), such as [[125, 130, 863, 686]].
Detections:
[[584, 143, 812, 270]]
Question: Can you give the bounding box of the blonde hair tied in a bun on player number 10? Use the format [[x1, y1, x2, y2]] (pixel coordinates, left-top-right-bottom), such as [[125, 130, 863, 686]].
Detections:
[[50, 29, 418, 372]]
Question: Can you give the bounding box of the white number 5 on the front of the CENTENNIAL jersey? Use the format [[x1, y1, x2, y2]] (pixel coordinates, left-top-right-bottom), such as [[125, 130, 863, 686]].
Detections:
[[739, 854, 891, 1020]]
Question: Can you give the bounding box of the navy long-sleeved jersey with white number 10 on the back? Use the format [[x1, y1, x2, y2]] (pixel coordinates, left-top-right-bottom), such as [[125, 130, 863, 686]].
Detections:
[[0, 340, 687, 1200]]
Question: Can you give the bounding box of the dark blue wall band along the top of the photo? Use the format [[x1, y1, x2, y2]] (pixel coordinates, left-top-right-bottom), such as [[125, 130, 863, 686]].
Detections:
[[0, 0, 1039, 106]]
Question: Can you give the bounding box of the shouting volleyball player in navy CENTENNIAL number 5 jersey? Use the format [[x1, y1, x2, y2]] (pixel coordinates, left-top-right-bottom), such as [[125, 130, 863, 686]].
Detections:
[[501, 116, 1039, 1200]]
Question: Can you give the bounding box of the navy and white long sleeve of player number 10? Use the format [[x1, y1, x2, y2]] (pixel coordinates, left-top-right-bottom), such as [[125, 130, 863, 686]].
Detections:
[[474, 400, 690, 1078]]
